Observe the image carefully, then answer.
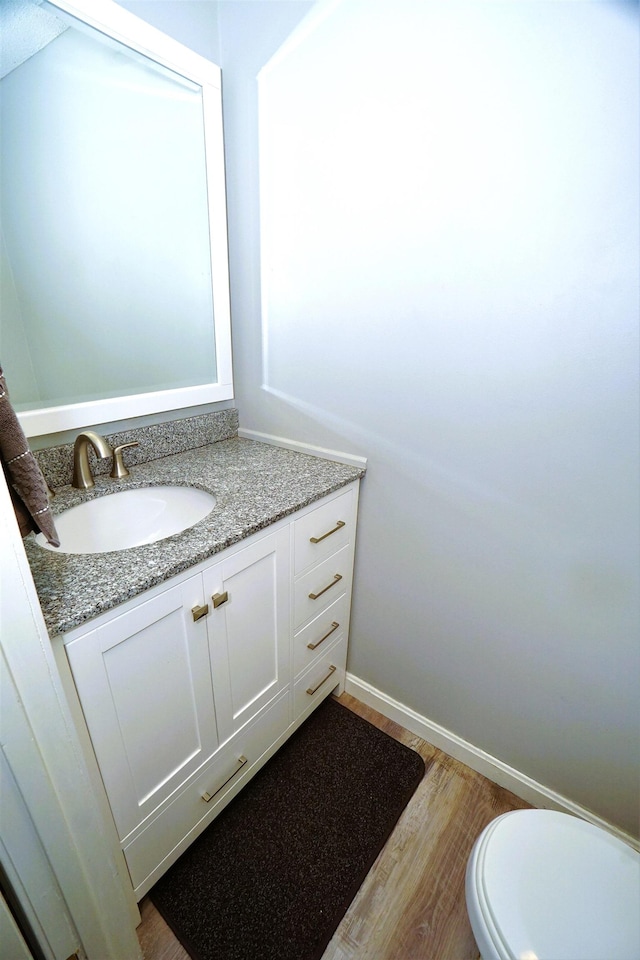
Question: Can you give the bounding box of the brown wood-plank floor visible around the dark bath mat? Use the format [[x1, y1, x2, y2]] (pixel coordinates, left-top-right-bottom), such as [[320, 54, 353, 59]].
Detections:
[[138, 694, 529, 960]]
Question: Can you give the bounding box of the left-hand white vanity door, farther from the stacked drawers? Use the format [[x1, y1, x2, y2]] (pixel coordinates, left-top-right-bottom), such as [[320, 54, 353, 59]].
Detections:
[[66, 576, 218, 840]]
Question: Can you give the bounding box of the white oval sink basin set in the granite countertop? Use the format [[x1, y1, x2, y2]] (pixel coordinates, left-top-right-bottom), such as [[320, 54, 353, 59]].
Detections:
[[36, 487, 216, 553]]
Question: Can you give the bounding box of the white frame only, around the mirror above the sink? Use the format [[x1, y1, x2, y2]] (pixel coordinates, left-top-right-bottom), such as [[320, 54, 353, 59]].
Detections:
[[18, 0, 233, 437]]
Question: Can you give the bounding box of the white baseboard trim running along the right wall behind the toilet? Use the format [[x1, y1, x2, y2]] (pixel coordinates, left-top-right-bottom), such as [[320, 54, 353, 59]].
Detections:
[[345, 673, 640, 850]]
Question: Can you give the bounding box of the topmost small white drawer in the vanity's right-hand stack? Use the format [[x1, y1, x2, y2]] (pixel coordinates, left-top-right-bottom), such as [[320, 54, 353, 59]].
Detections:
[[293, 490, 355, 575]]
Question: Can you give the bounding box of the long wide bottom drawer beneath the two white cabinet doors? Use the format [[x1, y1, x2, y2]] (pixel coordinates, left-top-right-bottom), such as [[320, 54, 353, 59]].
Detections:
[[124, 695, 289, 899]]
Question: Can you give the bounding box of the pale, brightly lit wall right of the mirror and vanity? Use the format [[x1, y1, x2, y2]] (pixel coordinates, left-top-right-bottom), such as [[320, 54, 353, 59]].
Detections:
[[219, 0, 640, 832]]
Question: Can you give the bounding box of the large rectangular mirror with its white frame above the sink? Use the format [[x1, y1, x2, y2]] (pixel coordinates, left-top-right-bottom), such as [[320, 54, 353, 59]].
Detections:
[[0, 0, 233, 436]]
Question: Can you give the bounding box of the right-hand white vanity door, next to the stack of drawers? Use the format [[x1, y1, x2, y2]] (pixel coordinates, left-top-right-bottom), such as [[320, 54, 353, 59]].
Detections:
[[203, 526, 290, 743]]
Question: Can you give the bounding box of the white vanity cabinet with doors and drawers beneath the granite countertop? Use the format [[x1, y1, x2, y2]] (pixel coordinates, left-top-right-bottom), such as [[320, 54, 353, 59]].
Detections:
[[62, 481, 358, 899]]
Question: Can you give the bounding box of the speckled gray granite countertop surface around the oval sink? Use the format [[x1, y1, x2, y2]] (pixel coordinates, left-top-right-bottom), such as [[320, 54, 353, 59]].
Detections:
[[25, 437, 365, 636]]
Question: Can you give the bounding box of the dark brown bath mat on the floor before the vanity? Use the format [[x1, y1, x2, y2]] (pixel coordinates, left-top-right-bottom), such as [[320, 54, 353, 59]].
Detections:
[[149, 698, 425, 960]]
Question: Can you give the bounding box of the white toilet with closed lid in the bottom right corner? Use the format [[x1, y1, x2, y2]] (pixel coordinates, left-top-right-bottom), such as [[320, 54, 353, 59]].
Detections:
[[466, 810, 640, 960]]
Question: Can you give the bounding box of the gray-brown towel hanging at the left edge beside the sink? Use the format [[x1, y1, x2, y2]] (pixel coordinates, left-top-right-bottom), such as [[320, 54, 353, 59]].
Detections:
[[0, 367, 60, 547]]
